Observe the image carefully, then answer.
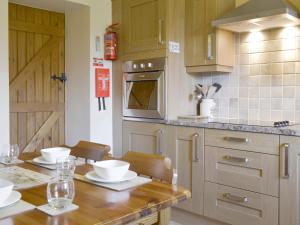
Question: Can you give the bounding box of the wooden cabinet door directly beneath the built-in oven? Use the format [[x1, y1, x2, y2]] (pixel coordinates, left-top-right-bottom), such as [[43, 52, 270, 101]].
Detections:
[[123, 121, 166, 155]]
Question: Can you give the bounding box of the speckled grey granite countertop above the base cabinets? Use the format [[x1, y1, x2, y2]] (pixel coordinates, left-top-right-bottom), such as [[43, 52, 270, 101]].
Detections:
[[123, 118, 300, 136]]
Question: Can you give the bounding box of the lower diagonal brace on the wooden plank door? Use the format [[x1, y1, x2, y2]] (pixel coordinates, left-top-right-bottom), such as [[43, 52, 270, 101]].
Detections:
[[23, 112, 60, 152]]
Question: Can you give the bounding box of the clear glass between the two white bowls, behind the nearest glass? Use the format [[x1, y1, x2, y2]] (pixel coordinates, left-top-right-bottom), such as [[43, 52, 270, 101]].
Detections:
[[56, 156, 76, 179]]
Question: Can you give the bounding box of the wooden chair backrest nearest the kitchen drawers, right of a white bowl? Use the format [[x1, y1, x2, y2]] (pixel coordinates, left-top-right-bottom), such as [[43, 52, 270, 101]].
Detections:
[[122, 151, 174, 184]]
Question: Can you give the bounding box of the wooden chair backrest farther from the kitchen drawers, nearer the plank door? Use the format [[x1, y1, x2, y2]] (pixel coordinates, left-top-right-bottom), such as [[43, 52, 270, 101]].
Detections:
[[69, 141, 110, 161]]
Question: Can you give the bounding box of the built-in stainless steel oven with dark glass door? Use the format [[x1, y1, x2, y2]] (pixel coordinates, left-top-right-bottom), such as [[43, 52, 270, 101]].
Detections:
[[123, 58, 166, 119]]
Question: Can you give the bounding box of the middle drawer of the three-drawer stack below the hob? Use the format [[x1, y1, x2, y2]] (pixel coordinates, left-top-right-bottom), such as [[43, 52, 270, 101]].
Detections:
[[205, 146, 279, 197]]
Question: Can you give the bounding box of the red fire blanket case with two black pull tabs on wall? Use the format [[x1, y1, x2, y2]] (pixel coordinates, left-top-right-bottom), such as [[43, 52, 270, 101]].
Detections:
[[95, 68, 110, 111]]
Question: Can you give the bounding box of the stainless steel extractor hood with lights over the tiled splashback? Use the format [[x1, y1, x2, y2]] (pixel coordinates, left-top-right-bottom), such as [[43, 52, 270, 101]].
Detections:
[[213, 0, 300, 32]]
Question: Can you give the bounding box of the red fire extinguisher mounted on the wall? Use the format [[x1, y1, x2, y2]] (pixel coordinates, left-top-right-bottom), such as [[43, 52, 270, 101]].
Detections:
[[104, 23, 118, 60]]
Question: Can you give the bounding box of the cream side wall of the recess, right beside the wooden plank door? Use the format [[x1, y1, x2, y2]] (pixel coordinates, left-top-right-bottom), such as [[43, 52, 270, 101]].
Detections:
[[65, 6, 90, 146]]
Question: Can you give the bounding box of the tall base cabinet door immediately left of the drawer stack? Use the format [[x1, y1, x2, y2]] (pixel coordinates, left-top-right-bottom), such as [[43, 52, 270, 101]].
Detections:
[[168, 126, 204, 215]]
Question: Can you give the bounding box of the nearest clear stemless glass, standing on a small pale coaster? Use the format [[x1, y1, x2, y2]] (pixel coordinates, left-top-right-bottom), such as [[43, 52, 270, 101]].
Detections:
[[47, 177, 75, 209]]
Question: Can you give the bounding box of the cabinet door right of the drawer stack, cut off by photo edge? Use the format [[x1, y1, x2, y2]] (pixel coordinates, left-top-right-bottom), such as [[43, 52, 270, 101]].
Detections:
[[279, 136, 300, 225]]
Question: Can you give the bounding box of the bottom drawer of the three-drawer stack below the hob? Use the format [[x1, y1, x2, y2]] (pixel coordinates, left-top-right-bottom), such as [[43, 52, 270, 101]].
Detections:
[[204, 182, 278, 225]]
